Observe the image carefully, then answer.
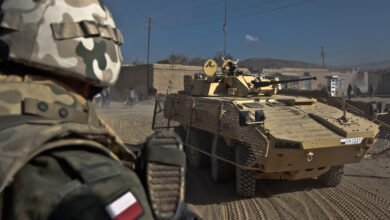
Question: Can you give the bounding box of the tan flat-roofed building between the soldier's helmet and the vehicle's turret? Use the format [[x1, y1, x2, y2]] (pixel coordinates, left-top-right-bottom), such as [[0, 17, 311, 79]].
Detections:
[[112, 63, 249, 100]]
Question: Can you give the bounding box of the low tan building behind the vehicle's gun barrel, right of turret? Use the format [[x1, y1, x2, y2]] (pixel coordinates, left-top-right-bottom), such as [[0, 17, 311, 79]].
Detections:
[[263, 68, 356, 96]]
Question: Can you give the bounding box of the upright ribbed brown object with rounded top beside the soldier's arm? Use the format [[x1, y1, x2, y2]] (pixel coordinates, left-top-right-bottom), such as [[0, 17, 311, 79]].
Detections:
[[145, 130, 186, 219]]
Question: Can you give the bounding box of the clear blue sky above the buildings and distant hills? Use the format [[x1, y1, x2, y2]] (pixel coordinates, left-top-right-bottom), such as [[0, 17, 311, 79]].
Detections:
[[105, 0, 390, 65]]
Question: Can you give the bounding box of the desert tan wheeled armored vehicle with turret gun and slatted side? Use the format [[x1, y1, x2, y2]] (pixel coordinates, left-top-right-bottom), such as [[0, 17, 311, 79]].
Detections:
[[155, 58, 379, 197]]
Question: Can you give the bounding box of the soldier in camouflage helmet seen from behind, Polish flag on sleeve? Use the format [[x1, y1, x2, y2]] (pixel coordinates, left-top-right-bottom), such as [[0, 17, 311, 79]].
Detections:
[[0, 0, 196, 219]]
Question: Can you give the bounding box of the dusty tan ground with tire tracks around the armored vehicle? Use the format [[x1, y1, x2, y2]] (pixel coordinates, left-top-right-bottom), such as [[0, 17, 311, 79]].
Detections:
[[98, 102, 390, 219]]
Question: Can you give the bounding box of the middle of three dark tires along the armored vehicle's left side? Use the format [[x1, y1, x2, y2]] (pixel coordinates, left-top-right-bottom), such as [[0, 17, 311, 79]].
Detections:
[[211, 137, 234, 182]]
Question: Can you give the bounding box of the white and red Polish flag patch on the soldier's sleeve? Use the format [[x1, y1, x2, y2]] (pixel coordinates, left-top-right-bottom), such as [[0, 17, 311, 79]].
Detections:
[[106, 192, 143, 220]]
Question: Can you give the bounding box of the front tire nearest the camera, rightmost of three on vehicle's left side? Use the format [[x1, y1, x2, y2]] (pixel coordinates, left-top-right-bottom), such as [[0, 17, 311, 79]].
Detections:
[[236, 145, 256, 197]]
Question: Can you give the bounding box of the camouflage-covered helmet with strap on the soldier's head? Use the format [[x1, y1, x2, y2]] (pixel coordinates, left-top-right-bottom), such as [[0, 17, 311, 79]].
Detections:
[[0, 0, 123, 86]]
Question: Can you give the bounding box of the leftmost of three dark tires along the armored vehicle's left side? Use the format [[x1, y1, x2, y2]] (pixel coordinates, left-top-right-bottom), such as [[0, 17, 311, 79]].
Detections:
[[186, 129, 211, 169]]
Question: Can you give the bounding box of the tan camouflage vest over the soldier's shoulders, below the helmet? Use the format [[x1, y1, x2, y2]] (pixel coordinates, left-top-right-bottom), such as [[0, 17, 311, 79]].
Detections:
[[0, 82, 135, 194]]
